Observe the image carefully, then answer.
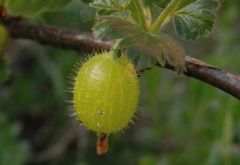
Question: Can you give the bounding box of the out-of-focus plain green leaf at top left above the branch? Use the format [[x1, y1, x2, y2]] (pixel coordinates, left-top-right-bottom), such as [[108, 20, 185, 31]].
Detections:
[[5, 0, 71, 17]]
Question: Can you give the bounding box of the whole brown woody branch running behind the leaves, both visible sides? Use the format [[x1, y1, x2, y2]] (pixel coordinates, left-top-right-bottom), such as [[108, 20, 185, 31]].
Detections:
[[0, 8, 240, 99]]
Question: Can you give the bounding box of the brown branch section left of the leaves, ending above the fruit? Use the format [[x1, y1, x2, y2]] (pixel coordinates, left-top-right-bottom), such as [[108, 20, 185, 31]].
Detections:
[[0, 6, 111, 52]]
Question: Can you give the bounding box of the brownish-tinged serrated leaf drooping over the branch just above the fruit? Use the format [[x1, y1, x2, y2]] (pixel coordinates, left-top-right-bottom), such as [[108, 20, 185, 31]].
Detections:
[[94, 16, 185, 72]]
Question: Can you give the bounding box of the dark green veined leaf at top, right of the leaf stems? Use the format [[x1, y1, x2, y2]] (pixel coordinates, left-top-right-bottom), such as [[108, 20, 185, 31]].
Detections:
[[173, 0, 219, 40]]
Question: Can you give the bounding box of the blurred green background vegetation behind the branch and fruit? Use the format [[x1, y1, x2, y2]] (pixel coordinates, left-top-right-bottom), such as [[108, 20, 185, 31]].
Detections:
[[0, 0, 240, 165]]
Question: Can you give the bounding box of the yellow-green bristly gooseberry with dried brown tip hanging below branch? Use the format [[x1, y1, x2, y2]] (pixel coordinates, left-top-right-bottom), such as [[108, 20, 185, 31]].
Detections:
[[73, 51, 139, 154]]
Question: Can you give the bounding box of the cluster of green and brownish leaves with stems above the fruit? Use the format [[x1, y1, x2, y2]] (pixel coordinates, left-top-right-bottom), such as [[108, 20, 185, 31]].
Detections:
[[91, 0, 219, 72]]
